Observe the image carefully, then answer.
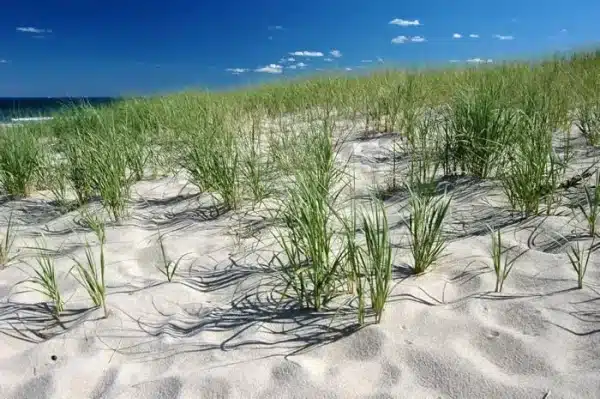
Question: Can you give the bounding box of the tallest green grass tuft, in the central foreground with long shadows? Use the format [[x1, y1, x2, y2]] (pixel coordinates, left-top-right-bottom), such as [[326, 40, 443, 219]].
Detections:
[[276, 113, 345, 311]]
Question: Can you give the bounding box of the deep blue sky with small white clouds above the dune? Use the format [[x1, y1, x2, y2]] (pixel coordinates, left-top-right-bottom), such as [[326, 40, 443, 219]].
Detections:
[[0, 0, 600, 97]]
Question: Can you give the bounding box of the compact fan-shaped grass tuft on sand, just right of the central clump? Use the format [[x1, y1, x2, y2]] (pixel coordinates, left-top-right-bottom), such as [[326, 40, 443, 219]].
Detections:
[[407, 192, 451, 274]]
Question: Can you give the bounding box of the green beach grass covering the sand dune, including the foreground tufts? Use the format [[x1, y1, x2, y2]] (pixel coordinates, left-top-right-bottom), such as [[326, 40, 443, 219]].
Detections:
[[0, 51, 600, 324]]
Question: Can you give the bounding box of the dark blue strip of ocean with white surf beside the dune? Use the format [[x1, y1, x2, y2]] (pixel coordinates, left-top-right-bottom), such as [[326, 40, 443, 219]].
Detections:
[[0, 97, 118, 123]]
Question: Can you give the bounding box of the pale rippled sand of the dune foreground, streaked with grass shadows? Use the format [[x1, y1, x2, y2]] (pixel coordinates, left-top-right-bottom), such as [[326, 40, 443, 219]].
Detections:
[[0, 122, 600, 399]]
